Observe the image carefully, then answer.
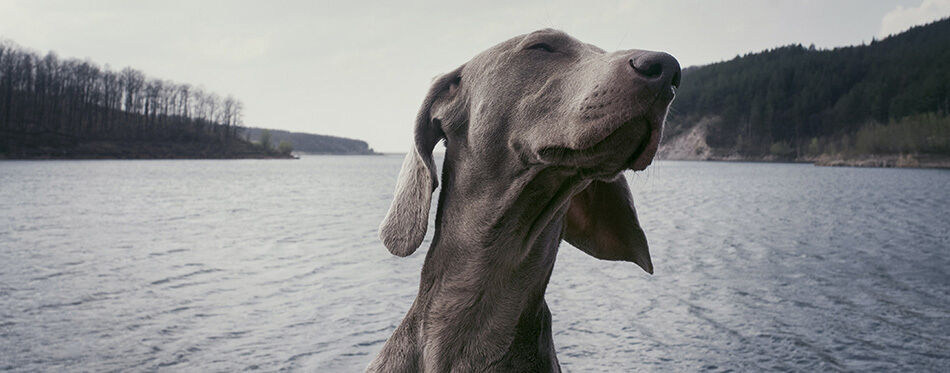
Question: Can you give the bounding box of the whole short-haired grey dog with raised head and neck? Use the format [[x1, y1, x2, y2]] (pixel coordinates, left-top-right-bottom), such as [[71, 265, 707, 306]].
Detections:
[[367, 30, 680, 372]]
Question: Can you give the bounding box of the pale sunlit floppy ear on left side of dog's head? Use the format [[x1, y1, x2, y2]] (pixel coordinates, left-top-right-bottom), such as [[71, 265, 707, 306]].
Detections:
[[379, 67, 462, 256]]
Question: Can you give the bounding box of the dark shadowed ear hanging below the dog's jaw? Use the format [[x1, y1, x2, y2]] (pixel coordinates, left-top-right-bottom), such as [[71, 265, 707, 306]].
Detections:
[[564, 174, 653, 274]]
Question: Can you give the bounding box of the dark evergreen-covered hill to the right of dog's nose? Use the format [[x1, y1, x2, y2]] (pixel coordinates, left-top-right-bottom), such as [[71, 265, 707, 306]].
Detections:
[[660, 19, 950, 165]]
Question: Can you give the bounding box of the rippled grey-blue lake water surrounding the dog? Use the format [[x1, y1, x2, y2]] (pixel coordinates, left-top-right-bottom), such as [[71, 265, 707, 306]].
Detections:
[[0, 155, 950, 372]]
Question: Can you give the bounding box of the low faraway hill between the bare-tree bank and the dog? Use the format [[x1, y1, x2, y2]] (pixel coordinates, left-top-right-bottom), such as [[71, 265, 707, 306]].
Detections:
[[244, 128, 377, 155]]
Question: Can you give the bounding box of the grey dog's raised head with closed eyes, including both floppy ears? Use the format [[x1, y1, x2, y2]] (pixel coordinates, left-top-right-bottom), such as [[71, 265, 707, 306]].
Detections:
[[380, 30, 680, 273]]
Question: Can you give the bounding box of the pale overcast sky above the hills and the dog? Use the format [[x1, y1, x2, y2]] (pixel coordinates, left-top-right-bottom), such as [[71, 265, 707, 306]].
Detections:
[[0, 0, 950, 152]]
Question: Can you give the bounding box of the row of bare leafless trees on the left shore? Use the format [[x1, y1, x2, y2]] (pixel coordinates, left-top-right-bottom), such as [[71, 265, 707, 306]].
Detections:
[[0, 40, 244, 141]]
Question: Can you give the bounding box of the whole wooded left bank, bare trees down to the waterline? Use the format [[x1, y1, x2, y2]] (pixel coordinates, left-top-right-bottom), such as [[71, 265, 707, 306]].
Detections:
[[0, 40, 282, 158]]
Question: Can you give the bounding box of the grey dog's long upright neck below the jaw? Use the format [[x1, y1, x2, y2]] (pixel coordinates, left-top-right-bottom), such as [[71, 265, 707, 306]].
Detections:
[[388, 152, 580, 371]]
